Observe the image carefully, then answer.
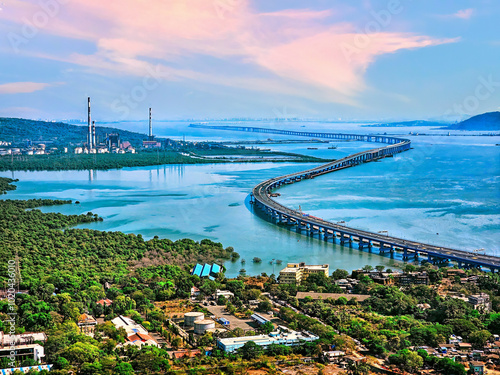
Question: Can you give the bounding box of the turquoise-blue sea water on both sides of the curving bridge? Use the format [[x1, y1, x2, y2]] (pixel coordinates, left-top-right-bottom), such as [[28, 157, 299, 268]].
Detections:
[[2, 122, 500, 276]]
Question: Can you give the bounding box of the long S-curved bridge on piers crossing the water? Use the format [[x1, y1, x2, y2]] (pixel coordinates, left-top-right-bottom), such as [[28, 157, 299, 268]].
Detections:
[[190, 124, 500, 272]]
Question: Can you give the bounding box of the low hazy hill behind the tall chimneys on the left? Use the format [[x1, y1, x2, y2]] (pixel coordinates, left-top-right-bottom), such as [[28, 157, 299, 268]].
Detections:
[[0, 117, 147, 146]]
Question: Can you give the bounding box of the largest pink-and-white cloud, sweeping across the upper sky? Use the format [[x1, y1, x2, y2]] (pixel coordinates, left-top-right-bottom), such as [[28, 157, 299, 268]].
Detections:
[[0, 0, 453, 105]]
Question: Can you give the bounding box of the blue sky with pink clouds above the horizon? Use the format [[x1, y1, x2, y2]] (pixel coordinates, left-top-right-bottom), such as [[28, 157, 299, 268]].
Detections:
[[0, 0, 500, 121]]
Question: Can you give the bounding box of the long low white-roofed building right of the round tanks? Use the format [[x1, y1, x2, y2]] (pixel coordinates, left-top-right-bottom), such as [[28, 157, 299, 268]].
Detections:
[[217, 326, 319, 353]]
